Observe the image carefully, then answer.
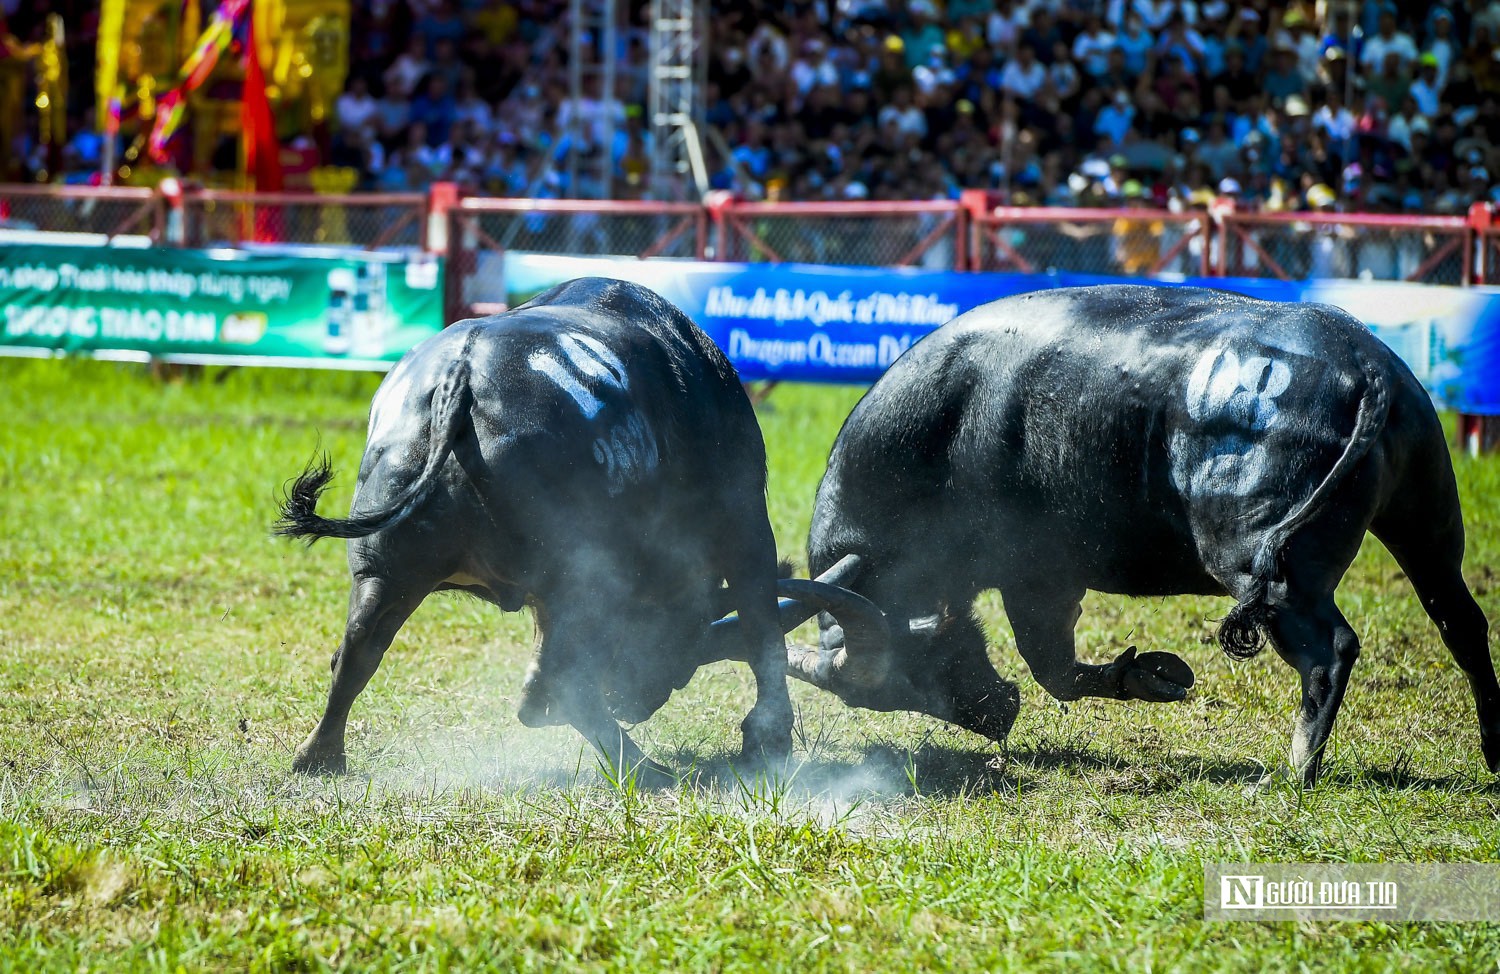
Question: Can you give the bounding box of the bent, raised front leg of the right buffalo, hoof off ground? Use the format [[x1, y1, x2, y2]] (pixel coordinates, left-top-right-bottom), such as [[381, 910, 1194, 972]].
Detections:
[[1001, 585, 1194, 702]]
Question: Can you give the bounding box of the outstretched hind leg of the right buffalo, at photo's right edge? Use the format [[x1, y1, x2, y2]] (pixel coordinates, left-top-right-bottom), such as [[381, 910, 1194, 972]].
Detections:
[[1374, 504, 1500, 774]]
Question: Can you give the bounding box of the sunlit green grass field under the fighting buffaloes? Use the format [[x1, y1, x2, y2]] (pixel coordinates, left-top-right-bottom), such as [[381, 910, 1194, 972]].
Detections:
[[0, 360, 1500, 971]]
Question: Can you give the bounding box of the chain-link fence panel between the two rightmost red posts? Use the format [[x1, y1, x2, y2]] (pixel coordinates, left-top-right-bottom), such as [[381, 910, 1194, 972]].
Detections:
[[1218, 213, 1470, 284]]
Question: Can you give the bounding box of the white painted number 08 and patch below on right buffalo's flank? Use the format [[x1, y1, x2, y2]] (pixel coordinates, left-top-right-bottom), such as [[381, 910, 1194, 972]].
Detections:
[[1170, 348, 1292, 495]]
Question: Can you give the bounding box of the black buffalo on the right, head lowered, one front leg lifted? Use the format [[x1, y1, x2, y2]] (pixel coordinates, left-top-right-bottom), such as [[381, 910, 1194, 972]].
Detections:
[[792, 280, 1500, 783]]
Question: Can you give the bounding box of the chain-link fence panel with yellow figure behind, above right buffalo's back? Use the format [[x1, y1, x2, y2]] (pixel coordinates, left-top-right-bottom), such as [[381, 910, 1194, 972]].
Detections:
[[974, 207, 1212, 278]]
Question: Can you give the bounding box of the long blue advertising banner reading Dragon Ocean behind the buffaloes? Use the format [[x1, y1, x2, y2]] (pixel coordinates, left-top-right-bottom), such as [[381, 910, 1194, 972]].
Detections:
[[504, 251, 1500, 414]]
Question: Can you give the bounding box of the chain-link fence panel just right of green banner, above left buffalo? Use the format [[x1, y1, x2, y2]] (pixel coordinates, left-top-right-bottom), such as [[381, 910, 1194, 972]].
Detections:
[[449, 197, 708, 314]]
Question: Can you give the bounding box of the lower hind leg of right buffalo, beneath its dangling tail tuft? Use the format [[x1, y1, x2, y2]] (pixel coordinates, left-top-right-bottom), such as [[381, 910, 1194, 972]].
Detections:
[[1269, 596, 1359, 788]]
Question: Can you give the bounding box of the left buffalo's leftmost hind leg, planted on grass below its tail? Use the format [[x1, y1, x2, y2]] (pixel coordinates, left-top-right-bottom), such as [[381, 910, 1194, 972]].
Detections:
[[291, 576, 423, 774]]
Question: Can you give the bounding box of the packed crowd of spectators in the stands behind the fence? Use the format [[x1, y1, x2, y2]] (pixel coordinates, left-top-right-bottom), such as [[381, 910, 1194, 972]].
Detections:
[[11, 0, 1500, 213]]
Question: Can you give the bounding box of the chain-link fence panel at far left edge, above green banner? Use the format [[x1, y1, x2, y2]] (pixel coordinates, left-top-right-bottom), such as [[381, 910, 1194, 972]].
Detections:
[[0, 186, 165, 240]]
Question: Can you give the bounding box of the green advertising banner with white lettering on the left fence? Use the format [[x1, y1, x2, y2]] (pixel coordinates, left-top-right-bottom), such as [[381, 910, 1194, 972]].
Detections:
[[0, 246, 446, 369]]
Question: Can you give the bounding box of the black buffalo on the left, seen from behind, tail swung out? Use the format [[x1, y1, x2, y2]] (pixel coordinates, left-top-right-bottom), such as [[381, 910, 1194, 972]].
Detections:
[[278, 279, 884, 785]]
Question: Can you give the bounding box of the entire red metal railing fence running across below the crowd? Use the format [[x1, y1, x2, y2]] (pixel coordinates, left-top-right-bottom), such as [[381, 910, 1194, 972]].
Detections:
[[0, 186, 1500, 301]]
